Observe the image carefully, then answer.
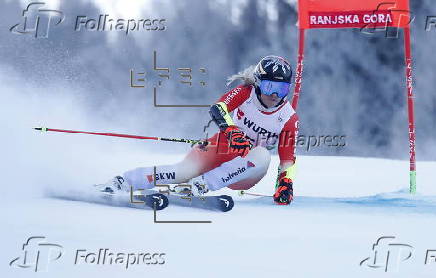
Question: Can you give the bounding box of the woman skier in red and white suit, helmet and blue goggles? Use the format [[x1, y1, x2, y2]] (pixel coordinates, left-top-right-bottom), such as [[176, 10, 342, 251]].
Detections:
[[99, 55, 298, 205]]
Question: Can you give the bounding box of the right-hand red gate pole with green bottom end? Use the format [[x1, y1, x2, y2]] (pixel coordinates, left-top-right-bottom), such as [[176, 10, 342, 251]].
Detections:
[[404, 27, 416, 194]]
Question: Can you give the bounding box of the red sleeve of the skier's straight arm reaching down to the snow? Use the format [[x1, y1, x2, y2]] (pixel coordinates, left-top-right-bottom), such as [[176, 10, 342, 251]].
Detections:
[[278, 113, 298, 163]]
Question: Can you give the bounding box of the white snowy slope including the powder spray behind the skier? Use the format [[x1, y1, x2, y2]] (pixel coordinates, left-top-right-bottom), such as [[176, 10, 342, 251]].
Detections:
[[0, 76, 436, 278]]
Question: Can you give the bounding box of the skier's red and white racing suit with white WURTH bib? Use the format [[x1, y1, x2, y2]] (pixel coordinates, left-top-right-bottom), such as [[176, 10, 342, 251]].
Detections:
[[123, 85, 298, 190]]
